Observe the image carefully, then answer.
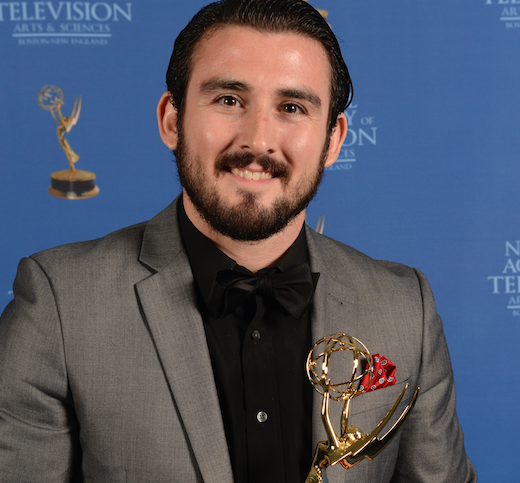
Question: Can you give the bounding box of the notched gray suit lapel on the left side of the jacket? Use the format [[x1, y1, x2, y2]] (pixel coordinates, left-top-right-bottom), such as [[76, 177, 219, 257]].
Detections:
[[136, 199, 233, 483]]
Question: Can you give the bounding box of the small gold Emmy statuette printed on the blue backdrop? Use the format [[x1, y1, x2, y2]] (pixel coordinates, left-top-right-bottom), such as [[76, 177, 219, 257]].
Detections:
[[38, 85, 99, 200]]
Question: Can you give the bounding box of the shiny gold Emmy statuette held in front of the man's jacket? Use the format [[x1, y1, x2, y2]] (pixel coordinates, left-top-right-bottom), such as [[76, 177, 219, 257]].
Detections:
[[305, 333, 419, 483]]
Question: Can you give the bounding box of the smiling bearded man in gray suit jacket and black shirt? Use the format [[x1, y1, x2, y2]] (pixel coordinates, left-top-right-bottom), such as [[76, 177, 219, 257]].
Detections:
[[0, 0, 476, 483]]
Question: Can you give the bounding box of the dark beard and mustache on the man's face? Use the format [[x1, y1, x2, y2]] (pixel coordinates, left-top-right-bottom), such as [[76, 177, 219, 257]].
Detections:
[[174, 130, 330, 241]]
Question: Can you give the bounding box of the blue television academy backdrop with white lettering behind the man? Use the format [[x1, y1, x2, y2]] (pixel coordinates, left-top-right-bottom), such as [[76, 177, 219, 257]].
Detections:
[[0, 0, 520, 482]]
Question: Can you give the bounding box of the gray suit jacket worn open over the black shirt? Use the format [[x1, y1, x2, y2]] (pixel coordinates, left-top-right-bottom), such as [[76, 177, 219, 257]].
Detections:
[[0, 199, 476, 483]]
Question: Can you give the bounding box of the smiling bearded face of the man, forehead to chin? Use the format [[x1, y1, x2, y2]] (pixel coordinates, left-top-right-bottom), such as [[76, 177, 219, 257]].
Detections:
[[176, 27, 342, 240]]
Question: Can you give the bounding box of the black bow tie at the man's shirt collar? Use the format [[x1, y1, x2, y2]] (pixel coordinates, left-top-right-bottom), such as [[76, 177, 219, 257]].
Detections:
[[208, 262, 319, 319]]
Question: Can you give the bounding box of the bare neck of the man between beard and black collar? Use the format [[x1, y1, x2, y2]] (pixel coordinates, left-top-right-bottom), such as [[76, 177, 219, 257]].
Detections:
[[183, 192, 305, 273]]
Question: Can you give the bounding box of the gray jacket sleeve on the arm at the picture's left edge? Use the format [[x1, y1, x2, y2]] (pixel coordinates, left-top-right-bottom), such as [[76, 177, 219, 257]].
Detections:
[[0, 258, 79, 483]]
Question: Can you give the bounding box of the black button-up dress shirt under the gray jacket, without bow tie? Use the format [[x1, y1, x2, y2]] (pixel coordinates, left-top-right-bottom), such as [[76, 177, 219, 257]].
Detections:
[[179, 203, 318, 483]]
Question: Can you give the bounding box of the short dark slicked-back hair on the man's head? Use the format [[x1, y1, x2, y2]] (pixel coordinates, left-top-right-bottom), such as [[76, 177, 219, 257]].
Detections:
[[166, 0, 353, 132]]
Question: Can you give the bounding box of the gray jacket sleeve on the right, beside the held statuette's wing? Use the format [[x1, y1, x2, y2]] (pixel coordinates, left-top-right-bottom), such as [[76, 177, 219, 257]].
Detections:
[[392, 271, 477, 483]]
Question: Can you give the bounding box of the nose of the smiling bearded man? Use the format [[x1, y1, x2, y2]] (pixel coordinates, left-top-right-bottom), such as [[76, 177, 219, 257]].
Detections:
[[239, 107, 278, 156]]
